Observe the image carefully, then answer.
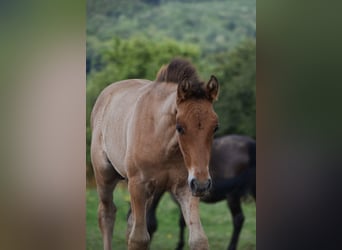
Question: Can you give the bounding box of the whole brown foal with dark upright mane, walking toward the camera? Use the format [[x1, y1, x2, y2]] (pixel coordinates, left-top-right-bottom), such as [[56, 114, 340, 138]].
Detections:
[[91, 59, 219, 250]]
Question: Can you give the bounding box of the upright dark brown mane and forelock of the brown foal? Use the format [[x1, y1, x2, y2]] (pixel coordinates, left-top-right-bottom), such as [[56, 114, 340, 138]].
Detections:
[[156, 58, 208, 99]]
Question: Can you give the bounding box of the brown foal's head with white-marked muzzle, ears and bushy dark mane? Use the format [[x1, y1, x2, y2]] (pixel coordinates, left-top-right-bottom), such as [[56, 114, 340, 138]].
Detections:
[[157, 60, 219, 196]]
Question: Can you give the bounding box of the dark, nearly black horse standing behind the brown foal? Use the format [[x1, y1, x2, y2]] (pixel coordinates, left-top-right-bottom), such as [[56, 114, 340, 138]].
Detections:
[[131, 135, 256, 250]]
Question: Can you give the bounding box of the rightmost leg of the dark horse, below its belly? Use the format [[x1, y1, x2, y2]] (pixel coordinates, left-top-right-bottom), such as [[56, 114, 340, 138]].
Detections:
[[227, 195, 245, 250]]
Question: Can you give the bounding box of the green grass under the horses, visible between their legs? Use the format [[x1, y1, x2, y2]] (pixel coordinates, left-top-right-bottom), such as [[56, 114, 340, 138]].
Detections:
[[86, 186, 256, 250]]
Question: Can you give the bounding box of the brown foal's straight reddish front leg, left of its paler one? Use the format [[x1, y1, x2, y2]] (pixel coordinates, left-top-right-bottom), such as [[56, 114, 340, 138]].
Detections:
[[128, 179, 150, 250]]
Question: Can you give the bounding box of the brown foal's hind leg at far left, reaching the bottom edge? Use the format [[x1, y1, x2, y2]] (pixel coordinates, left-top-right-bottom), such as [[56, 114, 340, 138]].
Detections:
[[92, 150, 121, 250]]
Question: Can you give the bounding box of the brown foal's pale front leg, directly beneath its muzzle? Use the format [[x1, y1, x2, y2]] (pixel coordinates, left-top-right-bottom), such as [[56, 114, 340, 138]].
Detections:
[[174, 186, 209, 250]]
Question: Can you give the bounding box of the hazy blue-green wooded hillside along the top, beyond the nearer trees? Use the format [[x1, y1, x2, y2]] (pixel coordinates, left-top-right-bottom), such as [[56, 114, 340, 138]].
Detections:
[[87, 0, 256, 53]]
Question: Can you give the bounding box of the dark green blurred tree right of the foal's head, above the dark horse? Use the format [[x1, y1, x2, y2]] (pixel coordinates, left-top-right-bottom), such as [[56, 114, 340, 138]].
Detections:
[[210, 40, 256, 138]]
